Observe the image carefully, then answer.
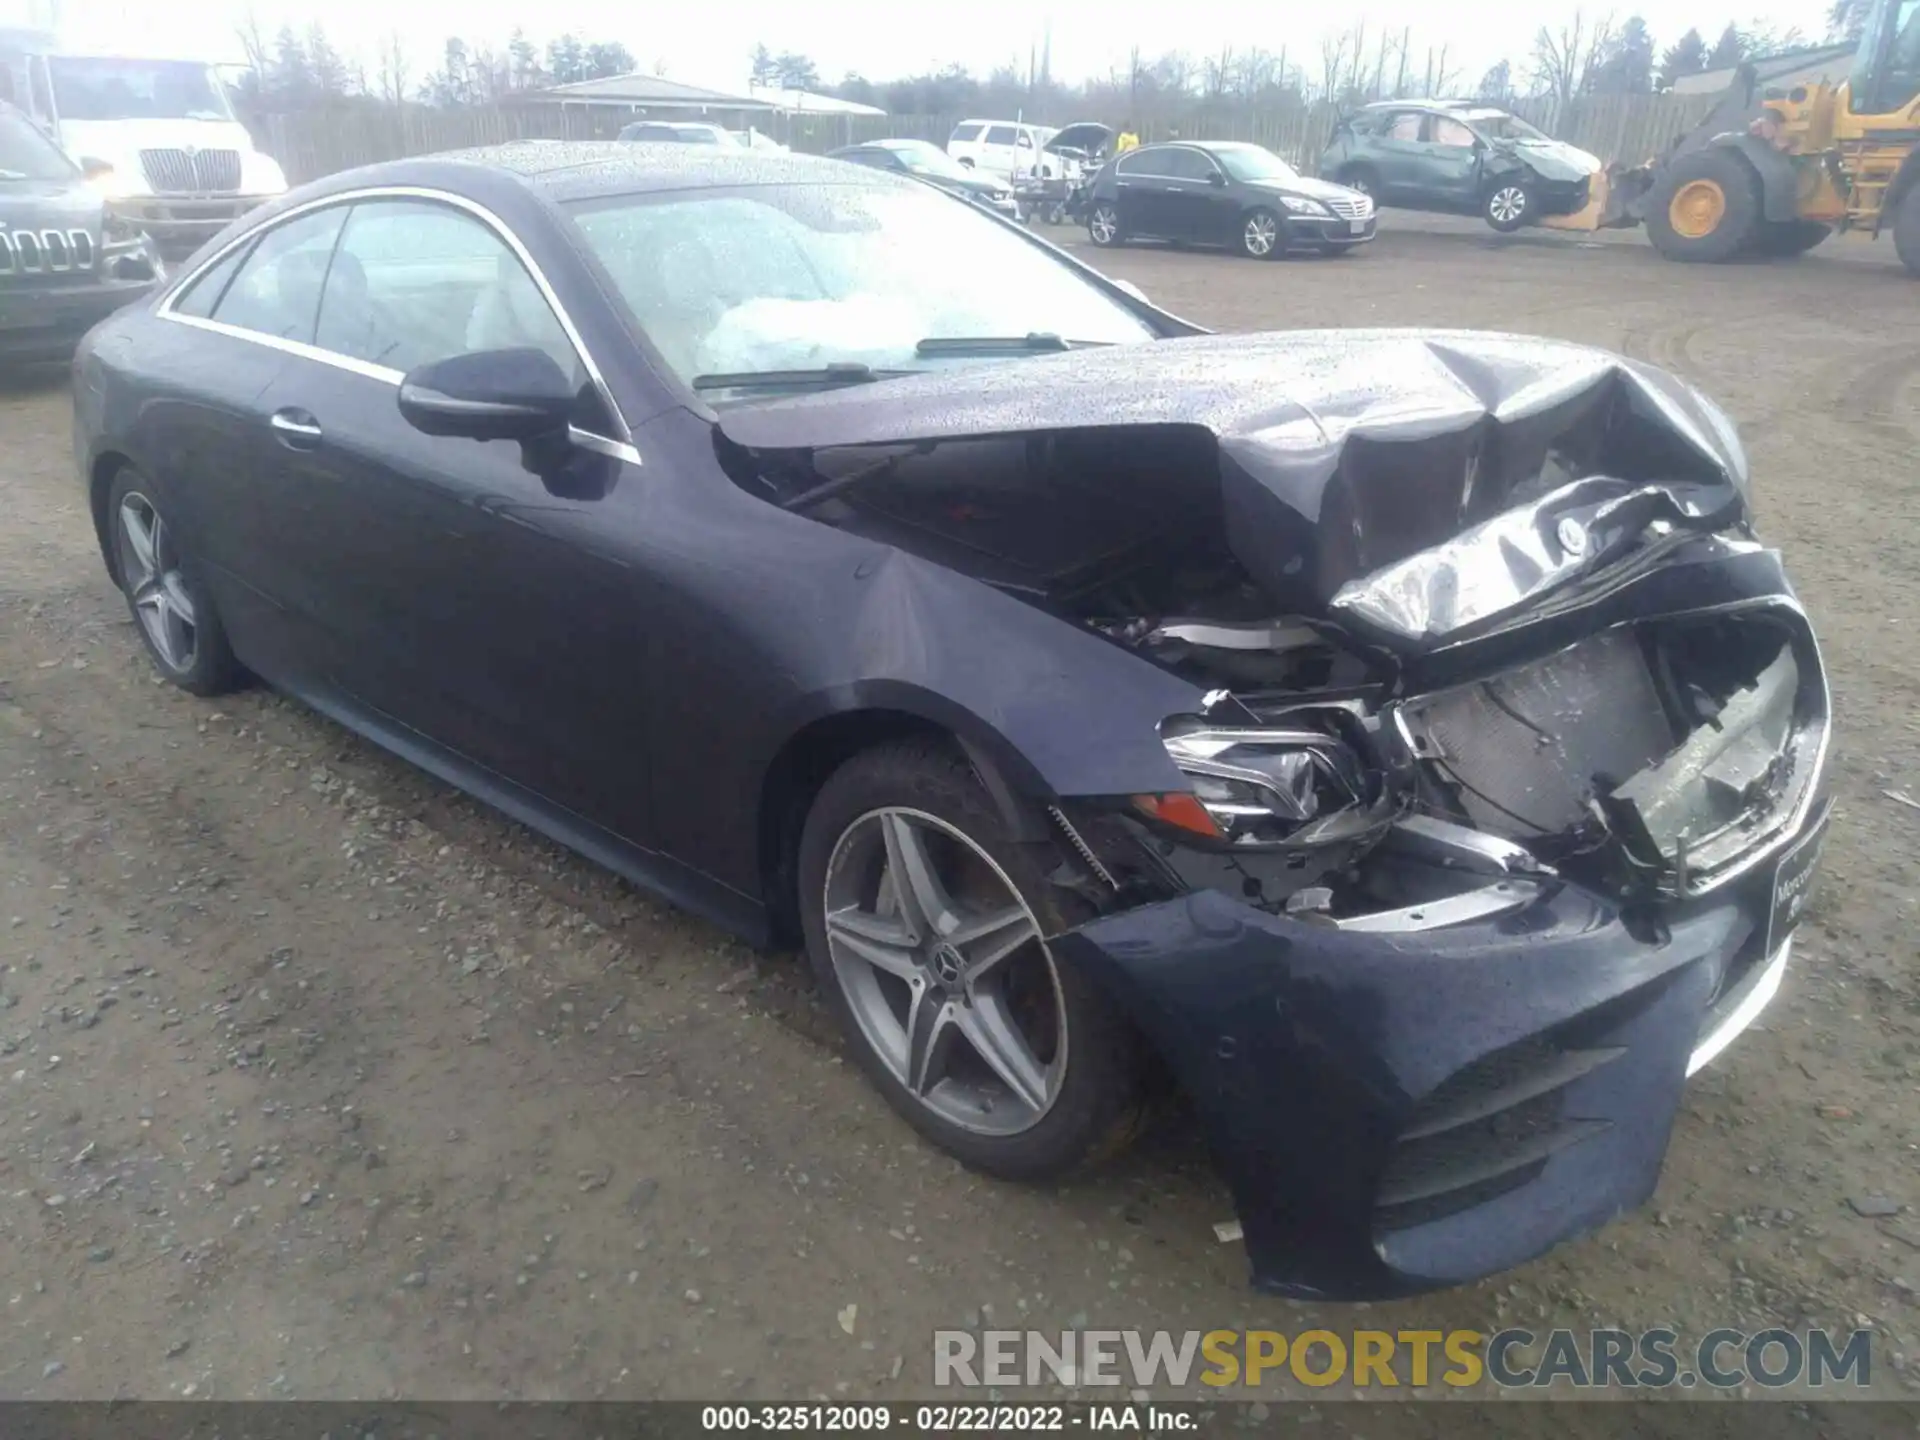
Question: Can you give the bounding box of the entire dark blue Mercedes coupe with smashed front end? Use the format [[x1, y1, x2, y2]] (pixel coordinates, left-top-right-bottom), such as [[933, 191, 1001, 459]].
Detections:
[[75, 142, 1828, 1296]]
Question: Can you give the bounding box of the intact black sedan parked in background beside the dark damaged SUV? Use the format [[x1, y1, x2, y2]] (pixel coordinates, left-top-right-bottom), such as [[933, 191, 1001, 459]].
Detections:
[[1087, 140, 1379, 259]]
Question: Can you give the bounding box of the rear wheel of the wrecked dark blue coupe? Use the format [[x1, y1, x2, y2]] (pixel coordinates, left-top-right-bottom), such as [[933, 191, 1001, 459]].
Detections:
[[106, 467, 242, 695]]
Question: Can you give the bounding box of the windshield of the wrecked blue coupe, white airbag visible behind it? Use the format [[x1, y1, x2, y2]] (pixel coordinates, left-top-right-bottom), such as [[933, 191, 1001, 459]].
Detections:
[[570, 182, 1154, 391]]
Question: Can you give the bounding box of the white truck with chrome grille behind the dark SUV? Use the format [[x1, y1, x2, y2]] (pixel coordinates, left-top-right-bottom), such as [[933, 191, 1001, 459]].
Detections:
[[0, 31, 286, 257]]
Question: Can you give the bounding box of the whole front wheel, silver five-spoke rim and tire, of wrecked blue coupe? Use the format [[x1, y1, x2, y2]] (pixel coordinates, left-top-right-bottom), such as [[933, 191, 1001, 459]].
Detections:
[[799, 741, 1142, 1179]]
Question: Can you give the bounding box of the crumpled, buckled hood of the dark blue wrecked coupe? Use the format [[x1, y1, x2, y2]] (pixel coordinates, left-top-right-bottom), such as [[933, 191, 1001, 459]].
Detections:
[[718, 330, 1745, 653]]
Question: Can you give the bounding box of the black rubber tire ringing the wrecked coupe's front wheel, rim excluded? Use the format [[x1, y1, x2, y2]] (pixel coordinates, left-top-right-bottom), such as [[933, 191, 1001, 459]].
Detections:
[[797, 741, 1146, 1181]]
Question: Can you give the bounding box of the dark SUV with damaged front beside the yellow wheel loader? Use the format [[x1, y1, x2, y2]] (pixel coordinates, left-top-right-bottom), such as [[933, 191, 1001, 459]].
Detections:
[[1319, 100, 1601, 232]]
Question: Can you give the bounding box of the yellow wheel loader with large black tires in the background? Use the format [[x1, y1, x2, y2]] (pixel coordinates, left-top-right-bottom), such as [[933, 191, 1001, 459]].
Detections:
[[1542, 0, 1920, 276]]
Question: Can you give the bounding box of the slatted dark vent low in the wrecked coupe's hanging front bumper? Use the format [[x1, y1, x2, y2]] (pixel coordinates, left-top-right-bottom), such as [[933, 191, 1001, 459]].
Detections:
[[1375, 1039, 1626, 1231]]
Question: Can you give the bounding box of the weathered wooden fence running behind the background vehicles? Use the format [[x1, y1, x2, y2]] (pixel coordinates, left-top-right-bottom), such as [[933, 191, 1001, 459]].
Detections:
[[253, 94, 1716, 184]]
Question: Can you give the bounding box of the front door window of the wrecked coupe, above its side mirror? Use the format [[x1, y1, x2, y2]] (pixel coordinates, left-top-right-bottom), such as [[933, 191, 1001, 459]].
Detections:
[[315, 200, 586, 382]]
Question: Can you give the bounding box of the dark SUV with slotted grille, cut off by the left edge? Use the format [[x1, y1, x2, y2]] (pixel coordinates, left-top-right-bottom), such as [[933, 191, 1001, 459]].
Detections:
[[0, 102, 161, 363]]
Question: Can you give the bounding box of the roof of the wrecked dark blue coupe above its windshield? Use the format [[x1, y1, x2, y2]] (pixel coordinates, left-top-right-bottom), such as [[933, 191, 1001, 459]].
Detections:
[[301, 140, 908, 202]]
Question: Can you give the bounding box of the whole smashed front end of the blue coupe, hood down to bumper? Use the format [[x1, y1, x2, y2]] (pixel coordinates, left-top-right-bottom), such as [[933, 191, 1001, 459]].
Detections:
[[722, 332, 1832, 1298]]
